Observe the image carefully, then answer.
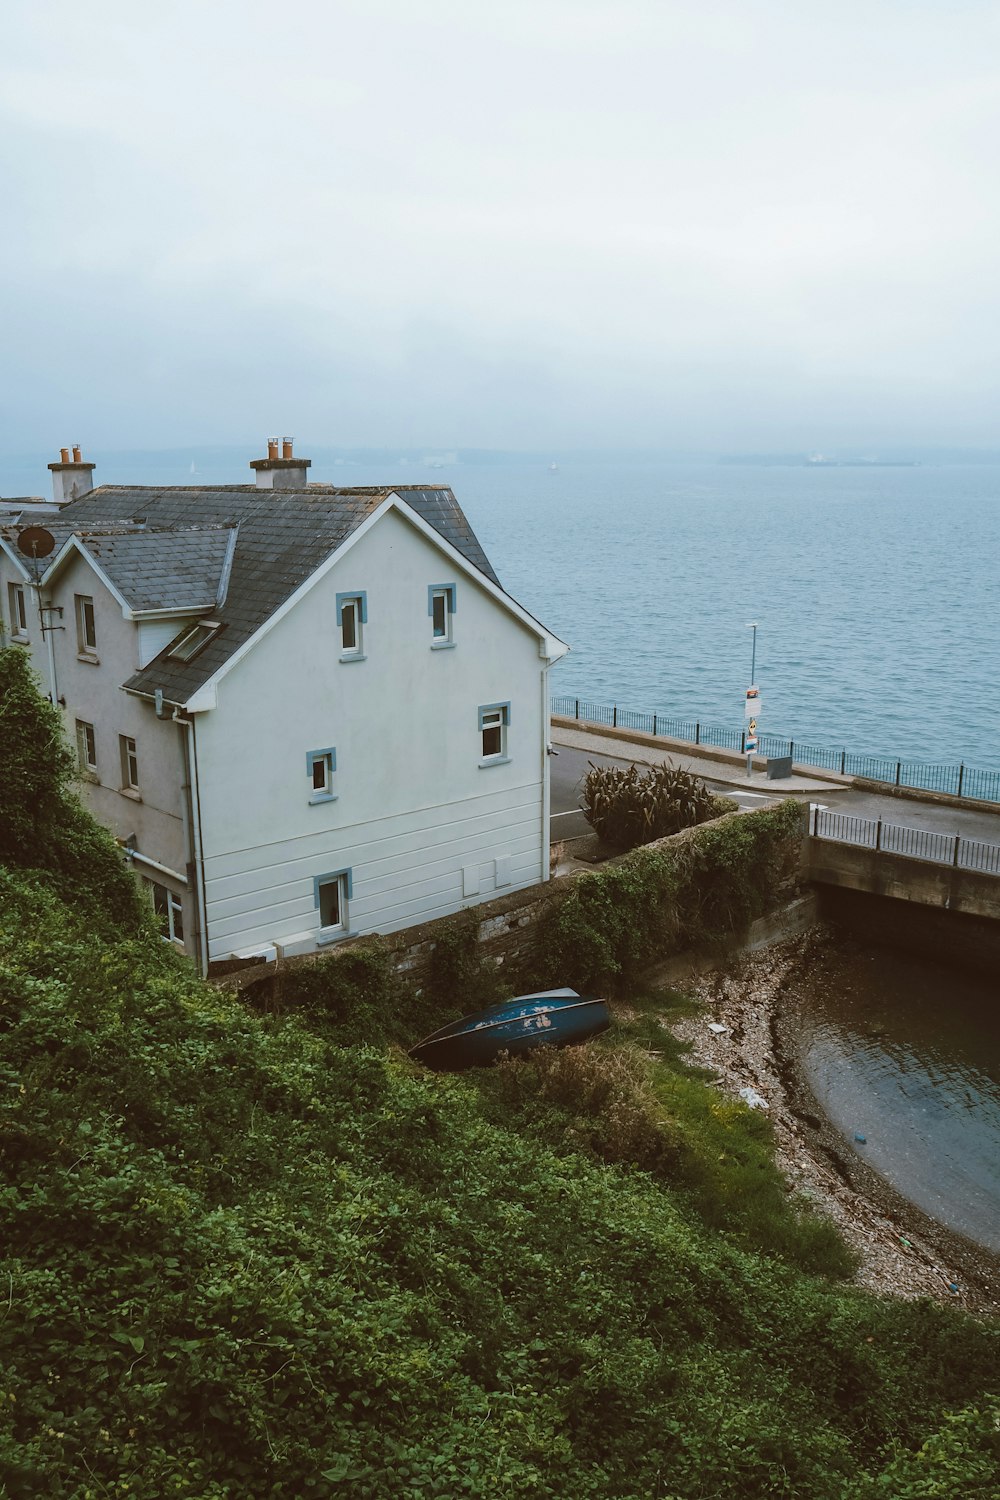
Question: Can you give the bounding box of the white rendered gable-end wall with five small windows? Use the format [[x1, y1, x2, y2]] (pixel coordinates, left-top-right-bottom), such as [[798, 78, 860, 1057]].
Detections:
[[196, 500, 547, 960]]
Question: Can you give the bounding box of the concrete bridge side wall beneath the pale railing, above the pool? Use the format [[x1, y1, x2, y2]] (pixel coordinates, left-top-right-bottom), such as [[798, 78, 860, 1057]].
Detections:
[[804, 839, 1000, 921]]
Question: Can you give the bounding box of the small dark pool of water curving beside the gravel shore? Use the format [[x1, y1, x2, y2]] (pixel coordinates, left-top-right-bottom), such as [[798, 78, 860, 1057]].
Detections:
[[793, 939, 1000, 1253]]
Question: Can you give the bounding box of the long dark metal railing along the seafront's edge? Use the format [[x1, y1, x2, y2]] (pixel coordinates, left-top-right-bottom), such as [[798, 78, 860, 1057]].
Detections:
[[552, 698, 1000, 803]]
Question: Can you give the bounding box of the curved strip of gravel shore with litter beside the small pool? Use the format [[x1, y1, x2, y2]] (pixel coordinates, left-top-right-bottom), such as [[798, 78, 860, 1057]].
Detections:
[[669, 929, 1000, 1317]]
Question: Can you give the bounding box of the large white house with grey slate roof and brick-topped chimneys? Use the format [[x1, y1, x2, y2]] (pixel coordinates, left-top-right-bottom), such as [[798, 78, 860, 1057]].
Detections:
[[0, 441, 568, 972]]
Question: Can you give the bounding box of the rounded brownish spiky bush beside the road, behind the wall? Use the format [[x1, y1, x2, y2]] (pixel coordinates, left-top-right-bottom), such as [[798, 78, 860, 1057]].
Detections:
[[583, 762, 733, 849]]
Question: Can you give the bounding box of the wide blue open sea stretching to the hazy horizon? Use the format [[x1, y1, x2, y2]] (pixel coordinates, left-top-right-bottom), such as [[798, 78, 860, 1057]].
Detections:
[[0, 449, 1000, 770]]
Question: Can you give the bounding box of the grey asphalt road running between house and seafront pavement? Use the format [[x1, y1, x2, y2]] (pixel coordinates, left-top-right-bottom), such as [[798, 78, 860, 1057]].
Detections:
[[550, 738, 1000, 845]]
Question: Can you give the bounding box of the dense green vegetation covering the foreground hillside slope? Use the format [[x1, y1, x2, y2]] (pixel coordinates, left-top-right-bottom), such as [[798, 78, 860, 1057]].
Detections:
[[0, 651, 1000, 1500]]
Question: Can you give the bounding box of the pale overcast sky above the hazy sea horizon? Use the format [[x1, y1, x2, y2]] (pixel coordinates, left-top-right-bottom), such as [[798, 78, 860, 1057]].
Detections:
[[0, 0, 1000, 452]]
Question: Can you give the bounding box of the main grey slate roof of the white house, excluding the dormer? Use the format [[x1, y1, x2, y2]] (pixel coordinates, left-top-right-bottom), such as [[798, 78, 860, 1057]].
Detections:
[[52, 485, 499, 705]]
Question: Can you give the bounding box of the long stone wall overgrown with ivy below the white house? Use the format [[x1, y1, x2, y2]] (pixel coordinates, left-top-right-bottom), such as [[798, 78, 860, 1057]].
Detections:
[[232, 801, 805, 1019]]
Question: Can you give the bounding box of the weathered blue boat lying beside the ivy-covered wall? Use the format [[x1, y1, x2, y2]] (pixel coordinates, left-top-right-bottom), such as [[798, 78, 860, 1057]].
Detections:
[[409, 990, 612, 1073]]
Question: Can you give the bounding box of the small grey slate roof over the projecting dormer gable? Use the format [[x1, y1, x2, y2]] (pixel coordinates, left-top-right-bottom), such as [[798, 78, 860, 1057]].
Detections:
[[78, 527, 238, 614]]
